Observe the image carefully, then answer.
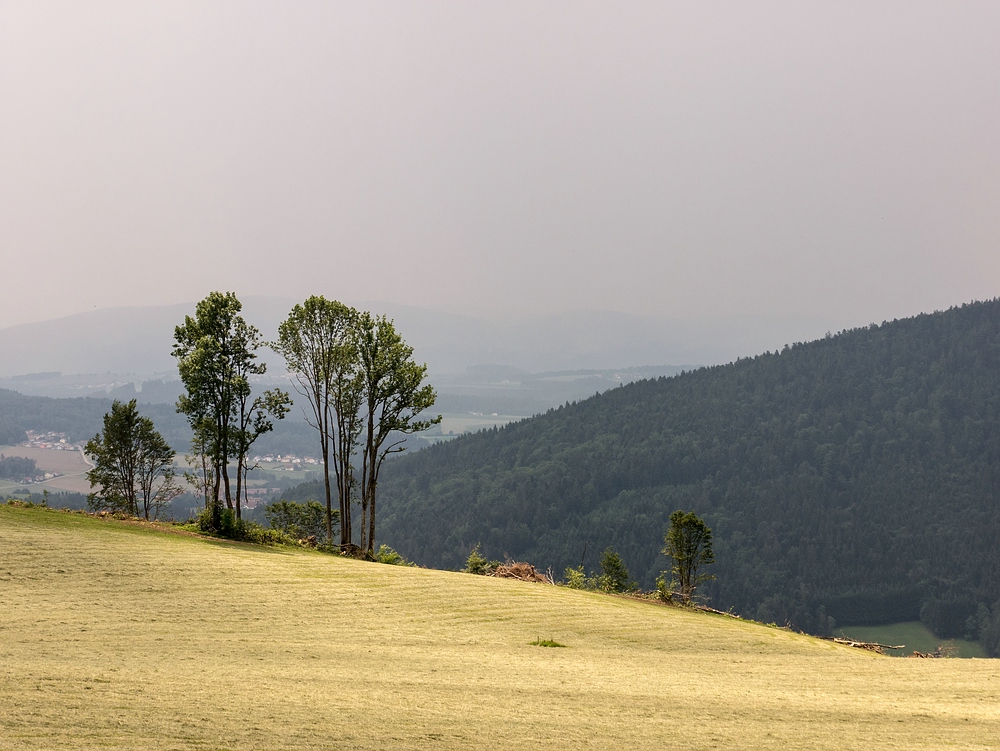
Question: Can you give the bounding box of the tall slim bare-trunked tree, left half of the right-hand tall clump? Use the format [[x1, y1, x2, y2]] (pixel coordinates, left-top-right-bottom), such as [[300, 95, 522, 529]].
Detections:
[[272, 296, 361, 545]]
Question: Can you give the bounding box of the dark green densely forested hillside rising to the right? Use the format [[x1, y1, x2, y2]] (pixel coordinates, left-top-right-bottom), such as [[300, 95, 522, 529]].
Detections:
[[380, 300, 1000, 636]]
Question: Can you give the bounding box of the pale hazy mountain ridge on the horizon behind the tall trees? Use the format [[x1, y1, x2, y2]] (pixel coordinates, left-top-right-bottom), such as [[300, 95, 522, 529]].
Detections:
[[0, 296, 840, 380]]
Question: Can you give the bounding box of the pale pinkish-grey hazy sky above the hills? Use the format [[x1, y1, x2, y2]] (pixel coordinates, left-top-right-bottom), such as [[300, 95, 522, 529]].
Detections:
[[0, 0, 1000, 326]]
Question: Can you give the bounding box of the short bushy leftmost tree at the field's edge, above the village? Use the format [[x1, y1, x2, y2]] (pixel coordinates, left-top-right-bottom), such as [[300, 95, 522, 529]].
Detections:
[[84, 399, 183, 520]]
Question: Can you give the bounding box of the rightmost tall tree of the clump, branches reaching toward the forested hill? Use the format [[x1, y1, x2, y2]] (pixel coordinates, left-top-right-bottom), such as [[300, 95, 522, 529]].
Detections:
[[357, 313, 441, 553]]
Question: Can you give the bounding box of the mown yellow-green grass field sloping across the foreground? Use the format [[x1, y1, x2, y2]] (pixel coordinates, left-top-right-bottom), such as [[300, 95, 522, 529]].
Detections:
[[0, 506, 1000, 751]]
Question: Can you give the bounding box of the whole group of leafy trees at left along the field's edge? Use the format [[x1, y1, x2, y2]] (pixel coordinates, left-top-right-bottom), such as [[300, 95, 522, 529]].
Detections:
[[85, 292, 441, 557]]
